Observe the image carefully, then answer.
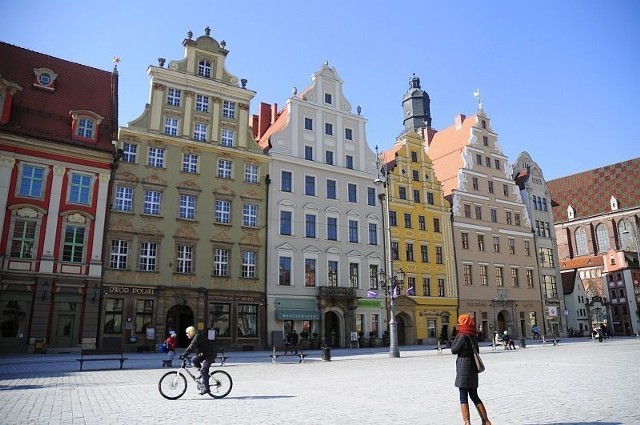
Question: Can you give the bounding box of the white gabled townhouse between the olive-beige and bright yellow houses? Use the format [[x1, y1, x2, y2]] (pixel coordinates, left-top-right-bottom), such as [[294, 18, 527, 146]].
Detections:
[[254, 62, 386, 347]]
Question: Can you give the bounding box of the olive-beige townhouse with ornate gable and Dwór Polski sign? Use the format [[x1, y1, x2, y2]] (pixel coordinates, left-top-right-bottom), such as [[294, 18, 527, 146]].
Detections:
[[104, 27, 268, 350]]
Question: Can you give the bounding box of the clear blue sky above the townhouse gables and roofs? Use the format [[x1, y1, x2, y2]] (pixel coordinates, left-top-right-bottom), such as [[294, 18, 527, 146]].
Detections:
[[0, 0, 640, 180]]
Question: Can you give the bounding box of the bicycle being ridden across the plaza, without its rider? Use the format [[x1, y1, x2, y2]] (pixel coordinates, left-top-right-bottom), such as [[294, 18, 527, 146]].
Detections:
[[158, 357, 233, 400]]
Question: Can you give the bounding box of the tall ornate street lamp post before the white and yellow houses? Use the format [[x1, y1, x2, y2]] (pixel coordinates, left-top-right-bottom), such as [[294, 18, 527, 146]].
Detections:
[[373, 146, 404, 358]]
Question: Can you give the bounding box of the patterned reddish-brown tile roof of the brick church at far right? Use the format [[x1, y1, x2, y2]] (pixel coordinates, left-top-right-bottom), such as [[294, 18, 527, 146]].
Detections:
[[547, 158, 640, 222]]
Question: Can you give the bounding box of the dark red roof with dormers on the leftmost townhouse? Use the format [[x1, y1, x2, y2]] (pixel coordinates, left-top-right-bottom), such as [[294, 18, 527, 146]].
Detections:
[[0, 42, 118, 151]]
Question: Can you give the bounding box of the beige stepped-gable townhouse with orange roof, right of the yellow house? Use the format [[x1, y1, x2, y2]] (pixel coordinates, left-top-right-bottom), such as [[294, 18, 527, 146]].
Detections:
[[427, 93, 543, 338]]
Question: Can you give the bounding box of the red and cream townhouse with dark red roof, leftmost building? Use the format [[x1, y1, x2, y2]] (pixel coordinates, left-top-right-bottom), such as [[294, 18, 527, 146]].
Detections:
[[0, 43, 118, 352]]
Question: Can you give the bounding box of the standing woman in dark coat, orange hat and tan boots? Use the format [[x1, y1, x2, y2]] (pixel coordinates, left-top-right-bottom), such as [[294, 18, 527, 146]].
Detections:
[[451, 314, 491, 425]]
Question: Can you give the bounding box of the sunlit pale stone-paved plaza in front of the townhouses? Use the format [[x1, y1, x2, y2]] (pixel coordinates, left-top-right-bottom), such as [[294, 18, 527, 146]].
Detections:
[[0, 338, 640, 425]]
